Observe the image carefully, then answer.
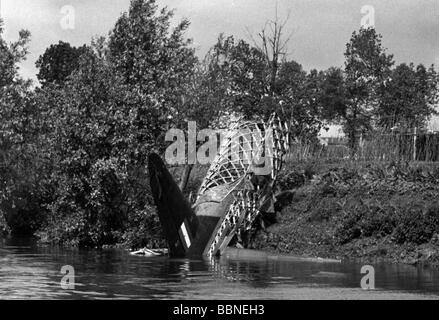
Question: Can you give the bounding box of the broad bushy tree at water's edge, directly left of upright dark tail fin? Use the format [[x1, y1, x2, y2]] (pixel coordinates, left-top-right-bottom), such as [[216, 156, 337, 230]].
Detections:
[[39, 50, 161, 246]]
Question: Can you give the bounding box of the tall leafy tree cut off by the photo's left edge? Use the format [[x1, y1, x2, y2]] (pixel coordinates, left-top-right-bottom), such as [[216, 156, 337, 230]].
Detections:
[[0, 20, 44, 234]]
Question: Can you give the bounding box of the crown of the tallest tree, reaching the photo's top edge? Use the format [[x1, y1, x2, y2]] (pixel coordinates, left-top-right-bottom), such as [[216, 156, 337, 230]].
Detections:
[[108, 0, 197, 128]]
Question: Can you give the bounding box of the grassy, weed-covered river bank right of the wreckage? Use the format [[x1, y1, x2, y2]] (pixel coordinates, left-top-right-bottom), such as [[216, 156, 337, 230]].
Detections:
[[253, 160, 439, 265]]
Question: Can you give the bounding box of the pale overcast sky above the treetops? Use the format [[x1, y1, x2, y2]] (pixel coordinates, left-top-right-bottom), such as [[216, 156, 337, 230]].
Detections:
[[0, 0, 439, 82]]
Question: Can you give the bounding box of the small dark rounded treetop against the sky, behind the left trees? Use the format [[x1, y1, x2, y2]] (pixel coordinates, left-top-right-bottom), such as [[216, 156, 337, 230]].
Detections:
[[36, 41, 87, 87]]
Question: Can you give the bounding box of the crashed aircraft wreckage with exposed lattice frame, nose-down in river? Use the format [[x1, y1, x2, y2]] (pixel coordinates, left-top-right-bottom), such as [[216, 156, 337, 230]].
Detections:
[[148, 114, 289, 257]]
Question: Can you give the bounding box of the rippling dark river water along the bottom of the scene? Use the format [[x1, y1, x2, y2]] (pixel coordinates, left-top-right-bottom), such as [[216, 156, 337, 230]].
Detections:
[[0, 239, 439, 299]]
